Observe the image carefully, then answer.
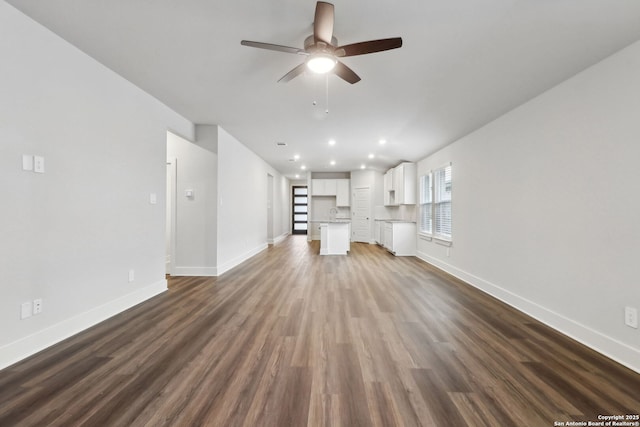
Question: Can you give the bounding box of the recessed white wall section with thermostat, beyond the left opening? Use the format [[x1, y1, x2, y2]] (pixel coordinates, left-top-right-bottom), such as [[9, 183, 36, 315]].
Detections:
[[167, 132, 218, 276]]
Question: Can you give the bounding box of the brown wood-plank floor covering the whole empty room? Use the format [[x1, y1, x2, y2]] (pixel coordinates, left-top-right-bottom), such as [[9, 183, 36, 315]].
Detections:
[[0, 236, 640, 427]]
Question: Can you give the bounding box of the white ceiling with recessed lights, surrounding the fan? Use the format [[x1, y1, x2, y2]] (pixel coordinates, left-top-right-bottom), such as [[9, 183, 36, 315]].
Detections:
[[8, 0, 640, 178]]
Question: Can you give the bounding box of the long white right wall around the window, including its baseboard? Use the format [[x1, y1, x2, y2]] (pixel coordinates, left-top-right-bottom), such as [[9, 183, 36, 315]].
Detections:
[[418, 43, 640, 371]]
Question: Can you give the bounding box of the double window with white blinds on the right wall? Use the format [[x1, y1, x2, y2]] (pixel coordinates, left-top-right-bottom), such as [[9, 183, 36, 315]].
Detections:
[[420, 165, 451, 241]]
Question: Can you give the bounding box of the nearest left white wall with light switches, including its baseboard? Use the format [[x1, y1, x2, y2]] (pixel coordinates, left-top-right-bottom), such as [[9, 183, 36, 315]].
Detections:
[[0, 2, 193, 367]]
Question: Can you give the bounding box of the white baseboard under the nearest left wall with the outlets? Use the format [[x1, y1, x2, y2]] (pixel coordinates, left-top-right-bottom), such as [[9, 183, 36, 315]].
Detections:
[[0, 279, 167, 369]]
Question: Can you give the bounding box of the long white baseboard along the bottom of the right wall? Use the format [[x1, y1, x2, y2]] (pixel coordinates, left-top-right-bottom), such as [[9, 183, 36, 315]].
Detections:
[[417, 252, 640, 373]]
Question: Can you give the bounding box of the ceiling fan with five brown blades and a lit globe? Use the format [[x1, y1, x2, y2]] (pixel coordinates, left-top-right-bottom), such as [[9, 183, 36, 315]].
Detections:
[[240, 1, 402, 84]]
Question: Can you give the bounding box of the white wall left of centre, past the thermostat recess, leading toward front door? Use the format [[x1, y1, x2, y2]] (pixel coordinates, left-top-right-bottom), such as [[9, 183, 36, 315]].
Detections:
[[217, 127, 289, 274]]
